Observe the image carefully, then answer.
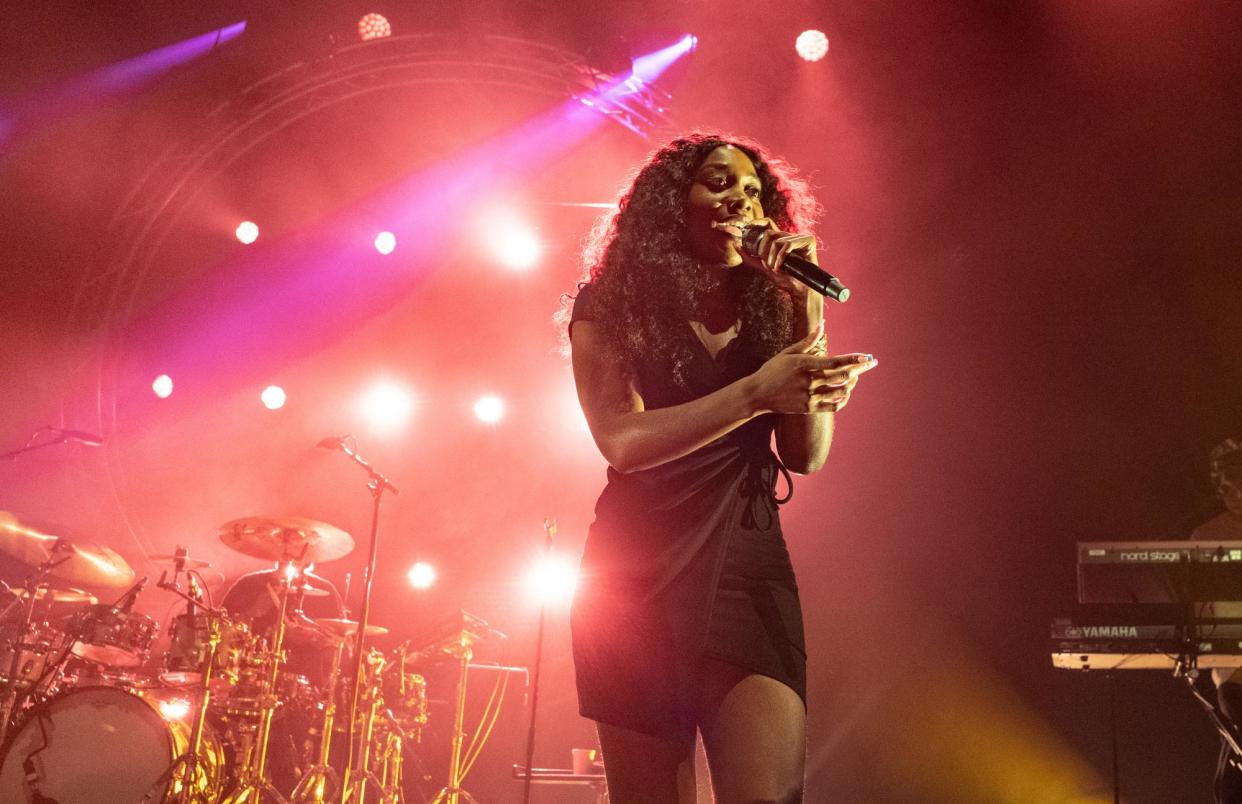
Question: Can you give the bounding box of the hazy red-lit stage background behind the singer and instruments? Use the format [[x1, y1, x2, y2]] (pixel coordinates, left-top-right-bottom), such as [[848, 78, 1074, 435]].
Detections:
[[0, 0, 1242, 803]]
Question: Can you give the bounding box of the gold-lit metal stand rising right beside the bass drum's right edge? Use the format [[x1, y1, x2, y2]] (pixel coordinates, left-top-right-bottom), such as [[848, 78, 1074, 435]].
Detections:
[[142, 554, 224, 804]]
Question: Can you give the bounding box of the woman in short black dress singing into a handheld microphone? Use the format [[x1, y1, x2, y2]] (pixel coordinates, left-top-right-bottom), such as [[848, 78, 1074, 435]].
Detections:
[[569, 134, 876, 804]]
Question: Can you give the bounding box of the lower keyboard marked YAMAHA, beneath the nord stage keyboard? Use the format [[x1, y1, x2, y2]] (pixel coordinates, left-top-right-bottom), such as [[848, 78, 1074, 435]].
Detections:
[[1052, 620, 1242, 670]]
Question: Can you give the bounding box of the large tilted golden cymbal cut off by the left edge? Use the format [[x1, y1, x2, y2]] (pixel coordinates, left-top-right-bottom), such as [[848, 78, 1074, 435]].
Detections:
[[0, 512, 134, 587]]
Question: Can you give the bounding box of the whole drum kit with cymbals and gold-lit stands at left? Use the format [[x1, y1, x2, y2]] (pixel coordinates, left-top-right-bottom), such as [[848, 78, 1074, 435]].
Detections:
[[0, 512, 449, 804]]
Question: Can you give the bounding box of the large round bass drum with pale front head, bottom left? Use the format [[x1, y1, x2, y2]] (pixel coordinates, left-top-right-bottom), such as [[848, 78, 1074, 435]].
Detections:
[[0, 687, 224, 804]]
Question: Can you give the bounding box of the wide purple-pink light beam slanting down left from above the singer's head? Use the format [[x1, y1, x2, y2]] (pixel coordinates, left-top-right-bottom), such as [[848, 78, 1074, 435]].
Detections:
[[110, 36, 693, 403]]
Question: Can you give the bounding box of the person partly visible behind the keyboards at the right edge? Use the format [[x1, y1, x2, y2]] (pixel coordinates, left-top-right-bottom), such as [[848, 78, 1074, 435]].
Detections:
[[1190, 439, 1242, 804]]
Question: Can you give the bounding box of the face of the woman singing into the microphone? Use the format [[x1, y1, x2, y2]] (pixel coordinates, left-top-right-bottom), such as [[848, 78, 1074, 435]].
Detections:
[[686, 145, 764, 267]]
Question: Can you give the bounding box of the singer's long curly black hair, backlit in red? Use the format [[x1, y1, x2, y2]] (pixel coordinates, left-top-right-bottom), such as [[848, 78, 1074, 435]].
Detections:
[[559, 133, 818, 386]]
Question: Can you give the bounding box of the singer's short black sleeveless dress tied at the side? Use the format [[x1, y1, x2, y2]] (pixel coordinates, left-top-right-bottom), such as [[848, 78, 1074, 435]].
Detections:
[[570, 285, 806, 739]]
